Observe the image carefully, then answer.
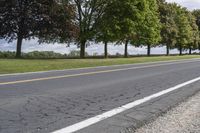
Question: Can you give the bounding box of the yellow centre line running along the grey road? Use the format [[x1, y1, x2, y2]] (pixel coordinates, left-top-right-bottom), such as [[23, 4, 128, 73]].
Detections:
[[0, 61, 200, 85]]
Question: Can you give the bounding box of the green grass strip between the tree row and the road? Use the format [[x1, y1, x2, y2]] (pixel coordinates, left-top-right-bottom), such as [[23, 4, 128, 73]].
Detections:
[[0, 55, 200, 74]]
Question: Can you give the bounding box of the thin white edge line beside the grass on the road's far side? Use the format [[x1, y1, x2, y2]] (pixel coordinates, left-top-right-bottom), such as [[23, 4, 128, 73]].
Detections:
[[0, 58, 200, 77]]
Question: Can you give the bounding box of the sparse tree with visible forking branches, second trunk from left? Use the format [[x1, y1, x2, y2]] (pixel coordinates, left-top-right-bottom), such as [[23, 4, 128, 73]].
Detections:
[[70, 0, 107, 58]]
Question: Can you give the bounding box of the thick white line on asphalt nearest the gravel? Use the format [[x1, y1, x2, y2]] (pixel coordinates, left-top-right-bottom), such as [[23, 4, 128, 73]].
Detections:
[[52, 77, 200, 133]]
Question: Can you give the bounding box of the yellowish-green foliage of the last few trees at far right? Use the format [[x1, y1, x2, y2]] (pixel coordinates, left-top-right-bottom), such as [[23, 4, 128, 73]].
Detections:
[[159, 1, 199, 54]]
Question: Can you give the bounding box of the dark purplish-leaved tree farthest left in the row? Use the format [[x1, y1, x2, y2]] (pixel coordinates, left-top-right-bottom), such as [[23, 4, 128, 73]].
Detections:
[[0, 0, 75, 58]]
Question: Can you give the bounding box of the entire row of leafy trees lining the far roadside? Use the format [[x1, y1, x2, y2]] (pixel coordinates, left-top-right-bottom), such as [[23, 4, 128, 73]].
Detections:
[[0, 0, 200, 58]]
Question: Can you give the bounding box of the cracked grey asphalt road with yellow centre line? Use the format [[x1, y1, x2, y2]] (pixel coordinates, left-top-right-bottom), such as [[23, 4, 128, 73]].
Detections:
[[0, 59, 200, 133]]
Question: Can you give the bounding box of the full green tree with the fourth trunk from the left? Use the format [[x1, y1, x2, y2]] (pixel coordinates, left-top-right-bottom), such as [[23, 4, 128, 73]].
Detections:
[[115, 0, 147, 58]]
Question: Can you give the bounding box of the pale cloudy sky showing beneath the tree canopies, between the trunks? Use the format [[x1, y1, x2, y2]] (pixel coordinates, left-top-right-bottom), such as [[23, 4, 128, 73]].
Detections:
[[0, 40, 185, 55]]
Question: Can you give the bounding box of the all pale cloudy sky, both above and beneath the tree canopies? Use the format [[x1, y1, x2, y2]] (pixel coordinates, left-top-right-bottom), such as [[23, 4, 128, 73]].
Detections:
[[0, 0, 200, 55]]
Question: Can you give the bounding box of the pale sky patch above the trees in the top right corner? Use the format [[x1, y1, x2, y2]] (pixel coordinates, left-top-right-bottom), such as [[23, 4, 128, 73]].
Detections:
[[166, 0, 200, 10]]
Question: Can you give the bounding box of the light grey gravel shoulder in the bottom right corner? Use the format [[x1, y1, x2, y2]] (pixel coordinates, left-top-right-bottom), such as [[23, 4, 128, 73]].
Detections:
[[135, 93, 200, 133]]
